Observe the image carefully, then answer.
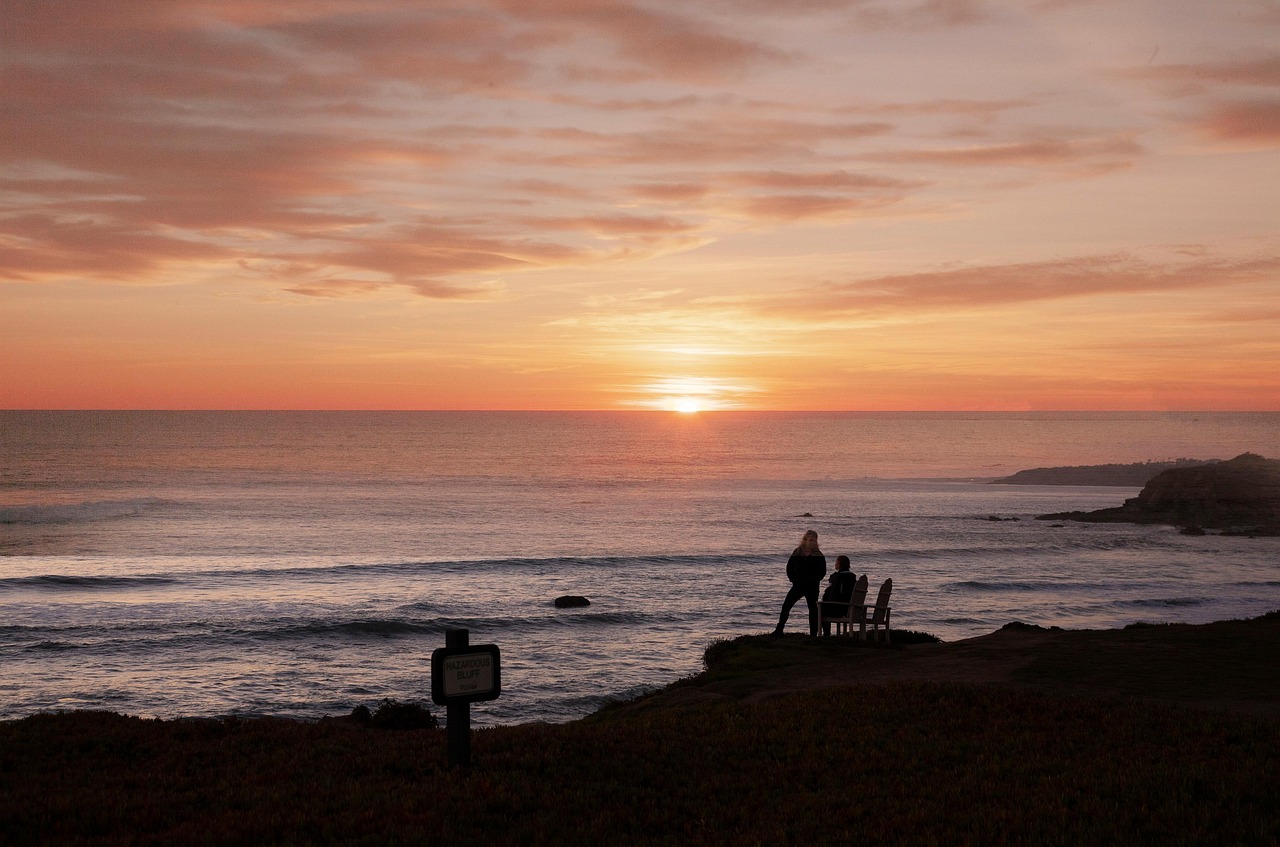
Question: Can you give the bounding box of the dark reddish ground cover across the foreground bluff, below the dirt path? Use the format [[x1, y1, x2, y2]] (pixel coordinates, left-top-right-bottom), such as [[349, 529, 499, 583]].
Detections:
[[0, 621, 1280, 844]]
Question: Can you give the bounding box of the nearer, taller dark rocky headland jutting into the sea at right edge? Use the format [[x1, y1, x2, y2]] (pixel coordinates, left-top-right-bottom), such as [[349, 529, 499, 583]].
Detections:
[[1037, 453, 1280, 535]]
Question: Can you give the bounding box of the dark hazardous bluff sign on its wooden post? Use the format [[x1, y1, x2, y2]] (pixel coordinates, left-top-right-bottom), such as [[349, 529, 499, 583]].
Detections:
[[431, 629, 502, 768]]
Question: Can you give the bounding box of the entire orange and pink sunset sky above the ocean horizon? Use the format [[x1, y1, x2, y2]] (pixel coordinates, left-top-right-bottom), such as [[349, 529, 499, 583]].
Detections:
[[0, 0, 1280, 411]]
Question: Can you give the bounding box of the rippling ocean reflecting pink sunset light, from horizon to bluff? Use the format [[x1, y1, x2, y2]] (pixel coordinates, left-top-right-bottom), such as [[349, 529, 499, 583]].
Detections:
[[0, 411, 1280, 725]]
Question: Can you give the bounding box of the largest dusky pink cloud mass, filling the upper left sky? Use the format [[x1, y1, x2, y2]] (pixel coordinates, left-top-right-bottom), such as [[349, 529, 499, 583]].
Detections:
[[0, 0, 888, 291]]
